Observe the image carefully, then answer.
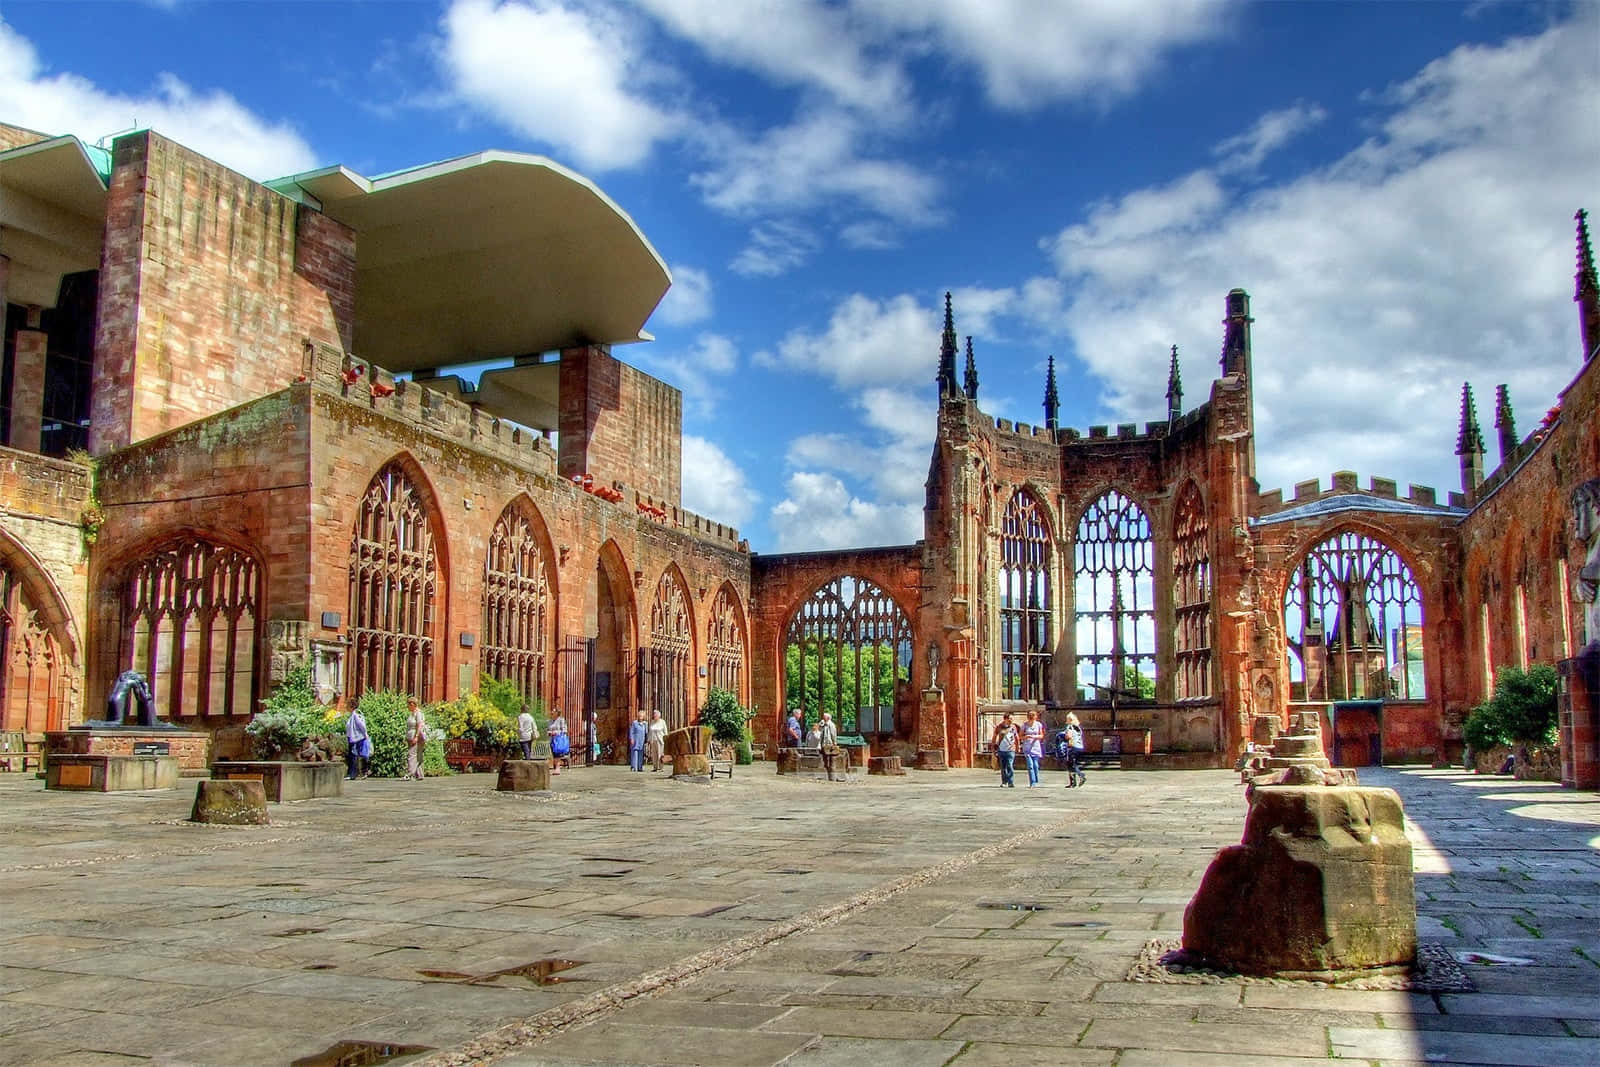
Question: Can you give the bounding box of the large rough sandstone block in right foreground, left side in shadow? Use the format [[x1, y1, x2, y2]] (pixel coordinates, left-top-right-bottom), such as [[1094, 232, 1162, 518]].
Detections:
[[1184, 785, 1416, 974]]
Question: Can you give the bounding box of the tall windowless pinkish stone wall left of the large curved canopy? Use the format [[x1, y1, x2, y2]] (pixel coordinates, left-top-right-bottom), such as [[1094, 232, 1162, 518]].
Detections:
[[90, 131, 355, 454]]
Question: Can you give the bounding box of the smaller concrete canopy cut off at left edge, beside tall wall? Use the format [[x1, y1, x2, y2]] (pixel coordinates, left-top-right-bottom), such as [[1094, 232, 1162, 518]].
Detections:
[[0, 136, 106, 307]]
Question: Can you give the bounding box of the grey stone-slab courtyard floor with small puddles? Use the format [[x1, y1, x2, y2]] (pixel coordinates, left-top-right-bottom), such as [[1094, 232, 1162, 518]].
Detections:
[[0, 765, 1600, 1067]]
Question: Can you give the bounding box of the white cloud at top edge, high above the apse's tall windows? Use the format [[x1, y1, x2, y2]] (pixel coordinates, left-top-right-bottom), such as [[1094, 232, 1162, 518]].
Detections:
[[854, 0, 1227, 110]]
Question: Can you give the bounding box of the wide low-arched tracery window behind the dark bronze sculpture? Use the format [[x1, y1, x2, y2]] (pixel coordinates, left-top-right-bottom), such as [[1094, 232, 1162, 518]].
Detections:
[[118, 537, 261, 718]]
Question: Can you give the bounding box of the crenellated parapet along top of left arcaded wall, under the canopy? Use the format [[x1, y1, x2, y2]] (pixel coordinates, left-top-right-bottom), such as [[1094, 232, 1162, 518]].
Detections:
[[306, 342, 749, 552]]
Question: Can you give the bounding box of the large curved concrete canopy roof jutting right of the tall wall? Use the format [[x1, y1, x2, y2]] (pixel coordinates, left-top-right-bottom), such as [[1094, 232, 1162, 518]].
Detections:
[[269, 152, 672, 371]]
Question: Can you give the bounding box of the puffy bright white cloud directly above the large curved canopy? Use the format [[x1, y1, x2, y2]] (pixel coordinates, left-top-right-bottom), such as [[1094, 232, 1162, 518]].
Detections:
[[440, 0, 683, 171]]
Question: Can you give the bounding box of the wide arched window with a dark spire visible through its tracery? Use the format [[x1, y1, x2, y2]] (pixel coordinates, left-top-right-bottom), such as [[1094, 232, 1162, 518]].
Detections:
[[1283, 530, 1426, 701]]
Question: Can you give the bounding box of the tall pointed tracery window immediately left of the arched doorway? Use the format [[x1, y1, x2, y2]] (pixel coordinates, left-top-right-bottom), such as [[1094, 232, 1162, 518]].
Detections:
[[478, 502, 550, 701]]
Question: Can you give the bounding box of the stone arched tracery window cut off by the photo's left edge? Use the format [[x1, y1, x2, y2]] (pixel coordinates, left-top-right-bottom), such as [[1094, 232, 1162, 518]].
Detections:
[[0, 530, 82, 733]]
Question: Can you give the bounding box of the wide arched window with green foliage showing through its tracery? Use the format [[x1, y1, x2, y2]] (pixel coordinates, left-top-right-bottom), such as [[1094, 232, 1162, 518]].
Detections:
[[782, 574, 912, 734]]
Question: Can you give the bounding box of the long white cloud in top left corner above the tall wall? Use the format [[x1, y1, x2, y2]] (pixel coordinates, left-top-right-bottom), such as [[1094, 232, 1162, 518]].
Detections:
[[0, 22, 317, 181]]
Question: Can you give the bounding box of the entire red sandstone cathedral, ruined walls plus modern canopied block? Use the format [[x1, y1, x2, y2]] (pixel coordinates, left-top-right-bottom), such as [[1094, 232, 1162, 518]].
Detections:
[[0, 126, 1600, 789]]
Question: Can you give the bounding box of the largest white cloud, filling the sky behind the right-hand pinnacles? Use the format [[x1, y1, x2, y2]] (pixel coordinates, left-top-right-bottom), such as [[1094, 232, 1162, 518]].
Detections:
[[1046, 16, 1600, 490]]
